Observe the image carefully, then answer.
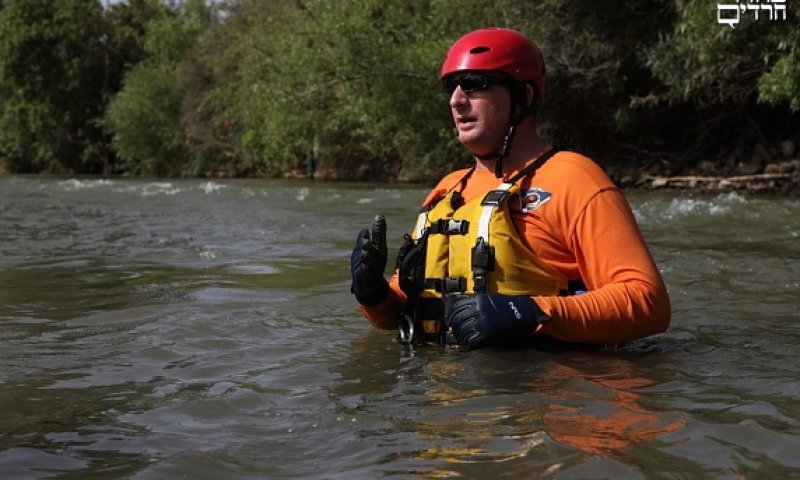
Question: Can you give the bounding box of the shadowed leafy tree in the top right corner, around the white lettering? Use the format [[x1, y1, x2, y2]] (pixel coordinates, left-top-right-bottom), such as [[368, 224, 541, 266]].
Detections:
[[632, 0, 800, 169]]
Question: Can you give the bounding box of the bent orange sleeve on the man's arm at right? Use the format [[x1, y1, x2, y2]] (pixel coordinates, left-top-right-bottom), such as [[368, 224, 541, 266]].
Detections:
[[534, 186, 671, 343]]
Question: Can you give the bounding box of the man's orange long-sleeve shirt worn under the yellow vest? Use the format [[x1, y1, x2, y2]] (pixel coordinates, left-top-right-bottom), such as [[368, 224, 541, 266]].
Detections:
[[361, 152, 671, 344]]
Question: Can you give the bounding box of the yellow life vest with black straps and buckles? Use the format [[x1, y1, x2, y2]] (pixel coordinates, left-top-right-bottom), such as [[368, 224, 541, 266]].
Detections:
[[397, 148, 568, 343]]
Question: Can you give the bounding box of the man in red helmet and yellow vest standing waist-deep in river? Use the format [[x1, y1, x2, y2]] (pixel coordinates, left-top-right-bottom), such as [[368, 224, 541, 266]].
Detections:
[[351, 28, 670, 348]]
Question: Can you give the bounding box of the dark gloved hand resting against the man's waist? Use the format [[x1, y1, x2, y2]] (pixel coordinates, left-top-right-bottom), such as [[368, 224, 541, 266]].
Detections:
[[447, 293, 550, 348]]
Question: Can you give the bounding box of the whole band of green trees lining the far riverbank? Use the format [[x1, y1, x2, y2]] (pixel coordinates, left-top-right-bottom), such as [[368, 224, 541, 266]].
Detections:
[[0, 0, 800, 179]]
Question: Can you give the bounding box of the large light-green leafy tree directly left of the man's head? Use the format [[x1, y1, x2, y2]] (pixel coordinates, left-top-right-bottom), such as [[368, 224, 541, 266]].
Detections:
[[195, 0, 512, 178]]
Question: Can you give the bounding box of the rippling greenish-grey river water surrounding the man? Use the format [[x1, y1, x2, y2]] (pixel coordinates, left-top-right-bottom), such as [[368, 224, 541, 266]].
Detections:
[[0, 177, 800, 479]]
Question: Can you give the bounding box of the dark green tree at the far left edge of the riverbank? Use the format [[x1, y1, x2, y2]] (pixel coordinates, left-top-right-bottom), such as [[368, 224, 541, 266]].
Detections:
[[0, 0, 108, 172]]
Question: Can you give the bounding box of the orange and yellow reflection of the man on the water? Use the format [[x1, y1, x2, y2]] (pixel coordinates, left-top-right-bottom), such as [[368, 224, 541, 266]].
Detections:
[[328, 331, 685, 478]]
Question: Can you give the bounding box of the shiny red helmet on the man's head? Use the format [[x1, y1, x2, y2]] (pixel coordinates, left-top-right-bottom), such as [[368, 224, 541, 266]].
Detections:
[[439, 27, 545, 97]]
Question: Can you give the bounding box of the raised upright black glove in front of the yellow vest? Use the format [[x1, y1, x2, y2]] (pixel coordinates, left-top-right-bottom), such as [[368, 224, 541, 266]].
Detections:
[[350, 215, 389, 307]]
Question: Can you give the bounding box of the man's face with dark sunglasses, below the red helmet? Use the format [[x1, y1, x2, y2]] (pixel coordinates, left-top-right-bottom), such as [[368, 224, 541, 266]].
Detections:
[[450, 73, 511, 155]]
